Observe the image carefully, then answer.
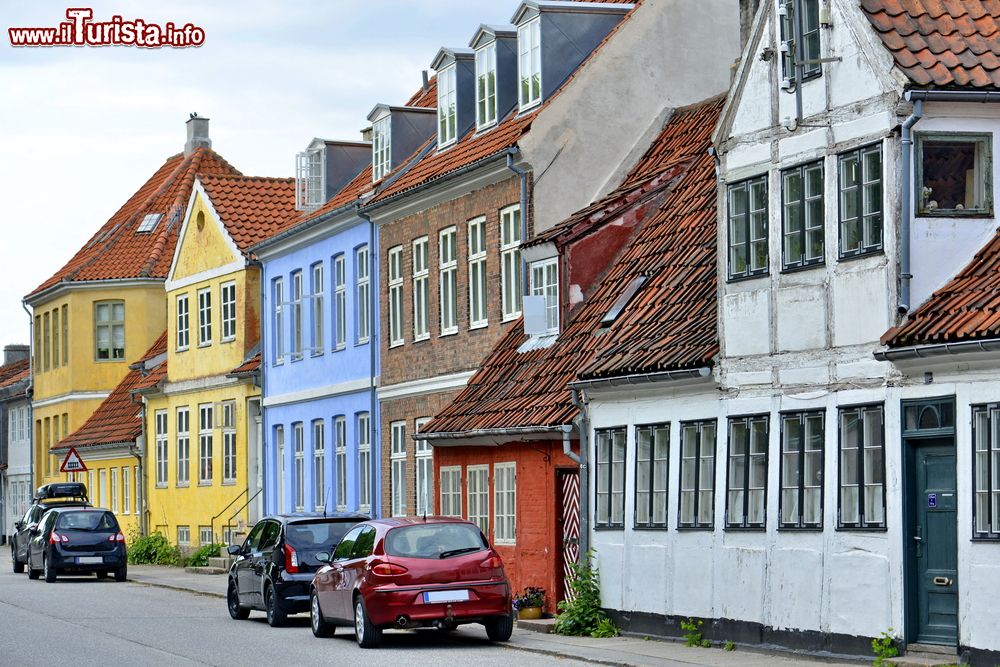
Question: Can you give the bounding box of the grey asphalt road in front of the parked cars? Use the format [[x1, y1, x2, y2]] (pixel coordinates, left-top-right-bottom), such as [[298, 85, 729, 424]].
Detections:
[[0, 546, 585, 667]]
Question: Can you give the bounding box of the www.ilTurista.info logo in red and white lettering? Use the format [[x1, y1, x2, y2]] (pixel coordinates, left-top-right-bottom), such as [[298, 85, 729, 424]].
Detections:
[[7, 7, 205, 49]]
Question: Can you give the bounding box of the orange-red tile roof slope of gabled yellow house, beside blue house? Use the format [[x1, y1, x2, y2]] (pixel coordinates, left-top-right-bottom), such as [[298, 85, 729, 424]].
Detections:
[[198, 175, 295, 253]]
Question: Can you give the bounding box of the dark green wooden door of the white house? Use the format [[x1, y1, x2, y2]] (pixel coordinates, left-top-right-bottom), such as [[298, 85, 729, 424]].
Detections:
[[909, 439, 958, 646]]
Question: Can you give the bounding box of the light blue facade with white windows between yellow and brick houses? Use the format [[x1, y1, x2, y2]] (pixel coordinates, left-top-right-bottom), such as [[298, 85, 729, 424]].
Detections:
[[258, 208, 381, 516]]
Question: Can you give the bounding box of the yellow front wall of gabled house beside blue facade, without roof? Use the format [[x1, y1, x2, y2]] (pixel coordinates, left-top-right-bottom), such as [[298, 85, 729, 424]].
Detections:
[[144, 191, 260, 547]]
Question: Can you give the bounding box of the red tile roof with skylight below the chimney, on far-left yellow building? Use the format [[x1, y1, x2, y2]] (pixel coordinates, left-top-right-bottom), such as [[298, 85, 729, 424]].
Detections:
[[28, 148, 240, 298]]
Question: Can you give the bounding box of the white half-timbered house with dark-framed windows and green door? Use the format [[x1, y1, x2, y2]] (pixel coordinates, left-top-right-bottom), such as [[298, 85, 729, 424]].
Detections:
[[578, 0, 1000, 665]]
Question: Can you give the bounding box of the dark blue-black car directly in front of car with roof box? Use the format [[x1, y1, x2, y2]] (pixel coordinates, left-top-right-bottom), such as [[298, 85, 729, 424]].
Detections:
[[27, 507, 128, 583]]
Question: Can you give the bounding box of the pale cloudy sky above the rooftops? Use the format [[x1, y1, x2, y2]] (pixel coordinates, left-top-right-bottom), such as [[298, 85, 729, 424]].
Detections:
[[0, 0, 500, 352]]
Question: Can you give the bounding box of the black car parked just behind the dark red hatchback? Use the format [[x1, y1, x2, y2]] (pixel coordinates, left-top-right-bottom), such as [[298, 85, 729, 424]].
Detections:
[[226, 512, 369, 627]]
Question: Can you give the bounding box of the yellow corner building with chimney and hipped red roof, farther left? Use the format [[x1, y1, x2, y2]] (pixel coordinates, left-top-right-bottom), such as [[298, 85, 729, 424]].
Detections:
[[24, 117, 239, 524]]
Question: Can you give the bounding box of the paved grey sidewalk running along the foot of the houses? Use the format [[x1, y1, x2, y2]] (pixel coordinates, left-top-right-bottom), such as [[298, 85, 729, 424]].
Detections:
[[128, 565, 866, 667]]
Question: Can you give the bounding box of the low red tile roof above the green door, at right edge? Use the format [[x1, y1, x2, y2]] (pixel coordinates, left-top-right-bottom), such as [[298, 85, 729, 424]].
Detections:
[[882, 230, 1000, 347]]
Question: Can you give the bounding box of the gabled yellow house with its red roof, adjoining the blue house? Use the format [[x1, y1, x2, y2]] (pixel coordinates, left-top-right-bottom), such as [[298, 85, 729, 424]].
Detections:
[[139, 176, 295, 548]]
